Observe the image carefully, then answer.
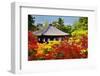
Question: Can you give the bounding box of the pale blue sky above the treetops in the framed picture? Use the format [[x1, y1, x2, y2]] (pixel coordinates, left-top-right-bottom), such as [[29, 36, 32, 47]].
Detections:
[[32, 15, 80, 25]]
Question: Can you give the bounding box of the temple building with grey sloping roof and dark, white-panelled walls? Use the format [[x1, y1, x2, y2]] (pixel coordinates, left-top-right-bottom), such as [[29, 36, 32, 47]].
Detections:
[[33, 24, 69, 43]]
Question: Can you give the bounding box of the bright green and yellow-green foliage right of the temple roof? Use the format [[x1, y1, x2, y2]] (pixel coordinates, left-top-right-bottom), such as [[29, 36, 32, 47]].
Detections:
[[71, 17, 88, 36]]
